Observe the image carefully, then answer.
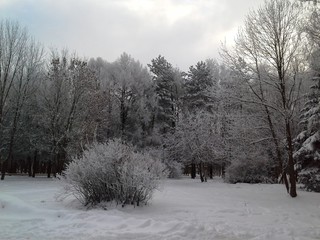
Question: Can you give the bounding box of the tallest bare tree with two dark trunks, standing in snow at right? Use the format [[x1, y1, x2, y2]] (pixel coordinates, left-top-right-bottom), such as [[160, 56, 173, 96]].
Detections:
[[224, 0, 303, 197]]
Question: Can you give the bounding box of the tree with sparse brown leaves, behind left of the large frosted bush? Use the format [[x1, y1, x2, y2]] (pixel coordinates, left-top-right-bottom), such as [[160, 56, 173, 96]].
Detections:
[[39, 51, 96, 177]]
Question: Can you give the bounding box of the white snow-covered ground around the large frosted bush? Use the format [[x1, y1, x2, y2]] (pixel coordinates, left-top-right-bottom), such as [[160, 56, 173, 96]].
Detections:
[[0, 176, 320, 240]]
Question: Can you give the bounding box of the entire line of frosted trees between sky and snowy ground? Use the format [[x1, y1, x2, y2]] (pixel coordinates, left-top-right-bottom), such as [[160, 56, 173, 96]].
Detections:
[[0, 0, 320, 197]]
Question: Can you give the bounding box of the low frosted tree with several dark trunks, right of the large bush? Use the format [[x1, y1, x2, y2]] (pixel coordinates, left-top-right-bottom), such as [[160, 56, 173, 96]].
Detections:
[[166, 111, 225, 182]]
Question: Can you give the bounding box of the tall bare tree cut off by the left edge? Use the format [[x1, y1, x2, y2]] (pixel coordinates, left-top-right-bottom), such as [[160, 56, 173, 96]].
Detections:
[[0, 20, 43, 180]]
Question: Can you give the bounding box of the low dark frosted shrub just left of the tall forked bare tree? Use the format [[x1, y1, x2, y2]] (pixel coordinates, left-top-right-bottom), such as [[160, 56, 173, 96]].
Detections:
[[225, 160, 272, 183]]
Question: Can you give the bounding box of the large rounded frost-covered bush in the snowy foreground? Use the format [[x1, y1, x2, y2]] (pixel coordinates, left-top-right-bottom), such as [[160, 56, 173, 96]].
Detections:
[[65, 140, 166, 206]]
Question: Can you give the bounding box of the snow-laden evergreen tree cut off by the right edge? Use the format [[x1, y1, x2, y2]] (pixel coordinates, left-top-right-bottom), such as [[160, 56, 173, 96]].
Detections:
[[294, 4, 320, 192]]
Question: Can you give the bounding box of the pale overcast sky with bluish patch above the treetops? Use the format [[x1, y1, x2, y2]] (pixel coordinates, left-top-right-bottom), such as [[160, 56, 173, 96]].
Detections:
[[0, 0, 263, 71]]
